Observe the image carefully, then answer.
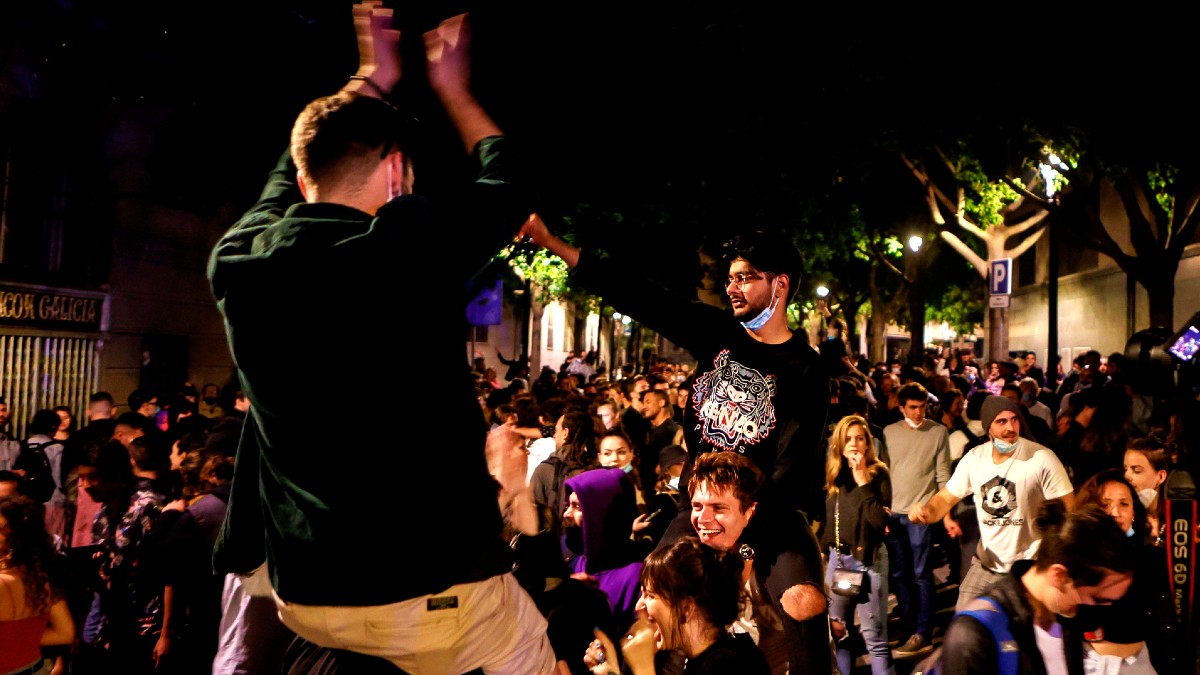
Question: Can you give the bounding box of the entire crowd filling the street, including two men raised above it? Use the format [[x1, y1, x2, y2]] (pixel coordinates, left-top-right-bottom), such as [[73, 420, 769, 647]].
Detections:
[[0, 4, 1195, 675]]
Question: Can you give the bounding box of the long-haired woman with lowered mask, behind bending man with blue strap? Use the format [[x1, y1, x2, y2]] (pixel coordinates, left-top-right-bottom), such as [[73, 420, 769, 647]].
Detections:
[[1075, 468, 1183, 675]]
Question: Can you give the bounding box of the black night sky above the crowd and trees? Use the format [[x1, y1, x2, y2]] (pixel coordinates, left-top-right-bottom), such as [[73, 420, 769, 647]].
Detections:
[[7, 0, 1190, 229]]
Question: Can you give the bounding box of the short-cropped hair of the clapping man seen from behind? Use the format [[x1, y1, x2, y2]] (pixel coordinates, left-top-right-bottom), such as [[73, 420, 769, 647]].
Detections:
[[292, 91, 410, 190]]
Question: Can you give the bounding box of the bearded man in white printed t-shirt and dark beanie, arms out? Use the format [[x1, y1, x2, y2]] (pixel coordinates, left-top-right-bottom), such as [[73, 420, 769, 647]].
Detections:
[[908, 396, 1075, 609]]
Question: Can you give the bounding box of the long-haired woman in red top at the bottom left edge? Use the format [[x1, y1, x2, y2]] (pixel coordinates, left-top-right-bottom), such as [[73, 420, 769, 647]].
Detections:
[[0, 495, 74, 675]]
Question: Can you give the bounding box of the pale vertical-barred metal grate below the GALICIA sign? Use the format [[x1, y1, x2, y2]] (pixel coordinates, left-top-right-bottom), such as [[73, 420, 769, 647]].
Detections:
[[0, 335, 100, 440]]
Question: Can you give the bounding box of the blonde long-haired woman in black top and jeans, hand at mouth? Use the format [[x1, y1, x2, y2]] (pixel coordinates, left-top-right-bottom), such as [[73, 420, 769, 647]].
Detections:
[[821, 414, 895, 675]]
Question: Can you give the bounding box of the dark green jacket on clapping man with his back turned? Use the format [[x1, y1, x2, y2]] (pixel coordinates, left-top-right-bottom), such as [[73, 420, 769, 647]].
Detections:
[[208, 137, 533, 605]]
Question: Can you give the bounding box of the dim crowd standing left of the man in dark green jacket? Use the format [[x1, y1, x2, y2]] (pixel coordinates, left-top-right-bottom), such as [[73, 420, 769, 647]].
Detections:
[[0, 383, 267, 674]]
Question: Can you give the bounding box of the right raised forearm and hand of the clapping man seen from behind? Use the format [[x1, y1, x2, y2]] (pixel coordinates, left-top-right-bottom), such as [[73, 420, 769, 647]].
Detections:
[[425, 14, 502, 153]]
